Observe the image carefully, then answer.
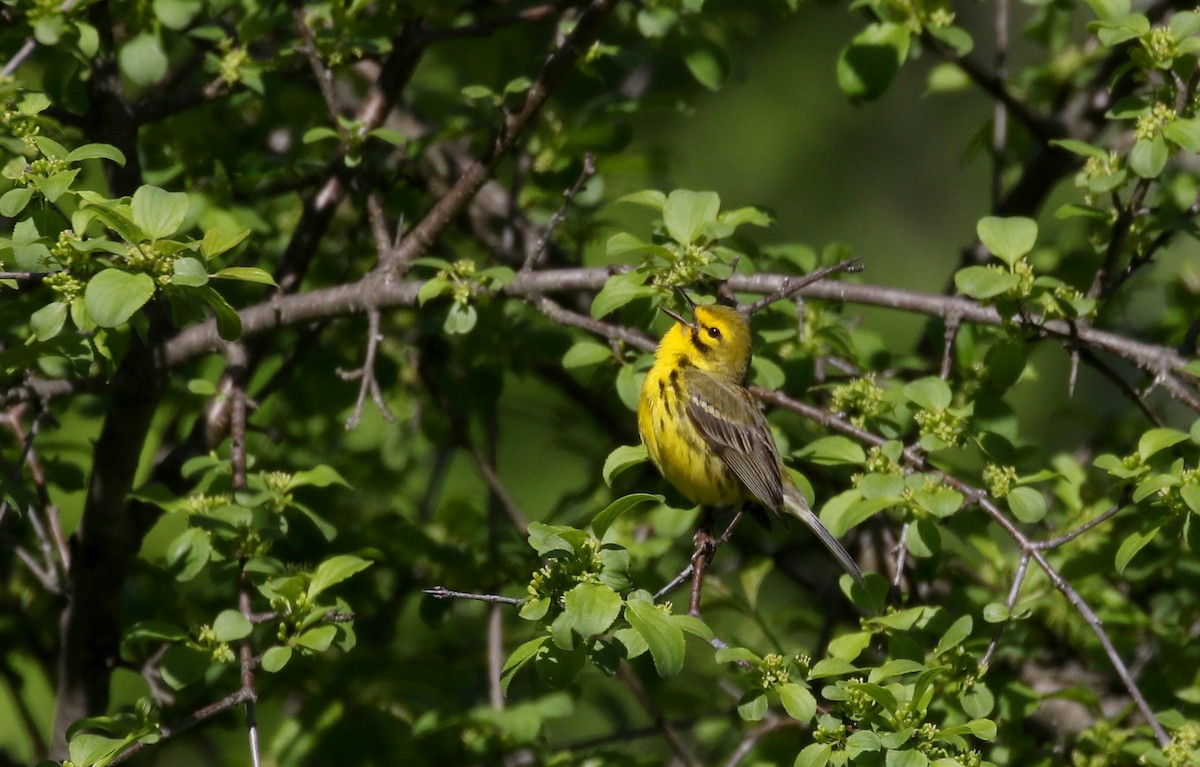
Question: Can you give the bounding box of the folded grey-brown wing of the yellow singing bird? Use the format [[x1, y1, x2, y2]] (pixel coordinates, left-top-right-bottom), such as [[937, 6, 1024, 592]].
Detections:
[[684, 367, 784, 514]]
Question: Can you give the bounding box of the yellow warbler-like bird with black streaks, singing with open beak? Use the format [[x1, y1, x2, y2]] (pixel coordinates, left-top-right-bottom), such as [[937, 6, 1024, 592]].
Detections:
[[637, 296, 863, 583]]
